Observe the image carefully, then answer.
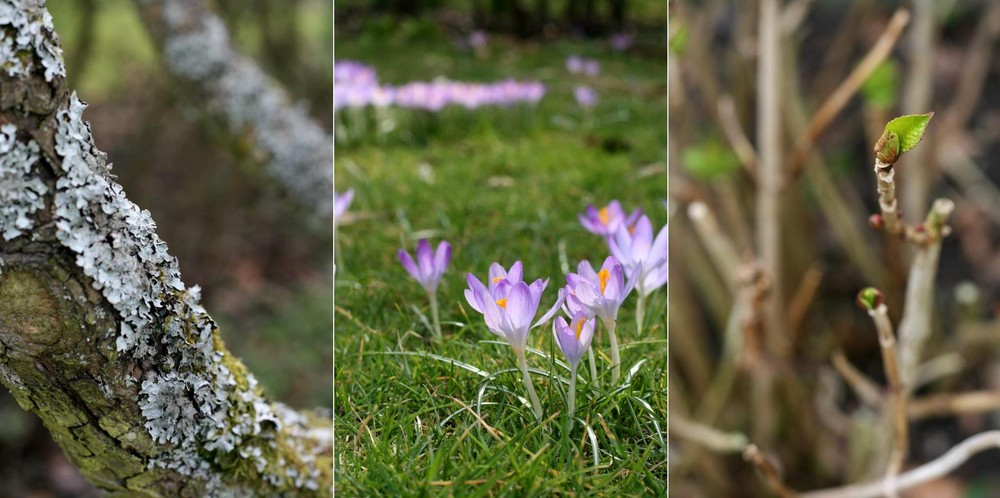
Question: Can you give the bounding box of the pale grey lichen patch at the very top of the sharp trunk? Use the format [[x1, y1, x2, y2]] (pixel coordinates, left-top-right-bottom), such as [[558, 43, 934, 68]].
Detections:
[[0, 0, 66, 81]]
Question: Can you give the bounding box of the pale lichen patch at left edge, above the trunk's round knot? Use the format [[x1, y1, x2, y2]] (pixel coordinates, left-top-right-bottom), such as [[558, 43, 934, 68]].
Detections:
[[0, 123, 47, 240]]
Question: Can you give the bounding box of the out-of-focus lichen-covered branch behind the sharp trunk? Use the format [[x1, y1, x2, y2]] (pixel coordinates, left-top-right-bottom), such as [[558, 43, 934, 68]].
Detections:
[[156, 2, 333, 216]]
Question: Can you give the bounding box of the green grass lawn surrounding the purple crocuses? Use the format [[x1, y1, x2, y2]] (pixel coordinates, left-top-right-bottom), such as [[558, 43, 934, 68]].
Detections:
[[334, 32, 667, 496]]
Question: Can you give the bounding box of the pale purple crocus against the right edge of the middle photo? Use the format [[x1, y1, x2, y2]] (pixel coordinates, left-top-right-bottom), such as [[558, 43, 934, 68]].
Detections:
[[608, 215, 667, 297]]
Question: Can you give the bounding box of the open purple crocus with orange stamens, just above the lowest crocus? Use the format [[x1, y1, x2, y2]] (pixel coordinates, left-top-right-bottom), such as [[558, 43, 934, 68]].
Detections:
[[566, 256, 642, 328]]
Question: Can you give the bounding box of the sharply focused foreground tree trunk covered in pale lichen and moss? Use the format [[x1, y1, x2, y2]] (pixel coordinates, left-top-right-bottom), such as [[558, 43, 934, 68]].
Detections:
[[0, 0, 333, 497]]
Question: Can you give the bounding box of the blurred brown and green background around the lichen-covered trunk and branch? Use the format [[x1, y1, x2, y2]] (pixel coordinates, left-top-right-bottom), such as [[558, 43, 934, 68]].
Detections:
[[0, 0, 333, 497]]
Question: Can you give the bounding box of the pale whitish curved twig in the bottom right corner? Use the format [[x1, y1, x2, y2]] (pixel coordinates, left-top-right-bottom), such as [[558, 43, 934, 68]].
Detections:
[[799, 431, 1000, 498]]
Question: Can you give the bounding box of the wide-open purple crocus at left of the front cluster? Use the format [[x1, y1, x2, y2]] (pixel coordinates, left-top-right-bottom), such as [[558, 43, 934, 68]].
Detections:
[[465, 261, 565, 355]]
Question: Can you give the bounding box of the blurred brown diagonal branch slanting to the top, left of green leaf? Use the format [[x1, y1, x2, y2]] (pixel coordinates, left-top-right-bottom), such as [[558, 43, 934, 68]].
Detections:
[[785, 9, 910, 179]]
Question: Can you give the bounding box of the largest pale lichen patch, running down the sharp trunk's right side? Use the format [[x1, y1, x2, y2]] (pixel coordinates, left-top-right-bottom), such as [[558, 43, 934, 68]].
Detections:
[[54, 94, 319, 494]]
